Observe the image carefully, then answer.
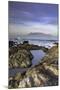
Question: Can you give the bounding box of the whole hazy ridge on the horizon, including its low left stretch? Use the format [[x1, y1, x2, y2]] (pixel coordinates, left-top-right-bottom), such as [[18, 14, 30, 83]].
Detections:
[[9, 32, 58, 41]]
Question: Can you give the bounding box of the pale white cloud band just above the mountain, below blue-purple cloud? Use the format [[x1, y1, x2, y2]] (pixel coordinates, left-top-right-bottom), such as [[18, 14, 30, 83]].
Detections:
[[9, 22, 58, 35]]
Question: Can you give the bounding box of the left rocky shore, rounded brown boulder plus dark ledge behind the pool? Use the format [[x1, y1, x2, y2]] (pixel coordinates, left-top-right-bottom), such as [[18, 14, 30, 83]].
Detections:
[[9, 43, 48, 68]]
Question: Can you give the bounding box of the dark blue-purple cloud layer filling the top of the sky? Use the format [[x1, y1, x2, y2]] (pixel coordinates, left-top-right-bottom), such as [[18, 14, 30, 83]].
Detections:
[[9, 2, 58, 25]]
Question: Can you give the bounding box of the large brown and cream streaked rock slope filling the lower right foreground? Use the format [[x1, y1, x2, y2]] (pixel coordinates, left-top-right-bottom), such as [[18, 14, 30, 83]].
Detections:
[[10, 46, 58, 88]]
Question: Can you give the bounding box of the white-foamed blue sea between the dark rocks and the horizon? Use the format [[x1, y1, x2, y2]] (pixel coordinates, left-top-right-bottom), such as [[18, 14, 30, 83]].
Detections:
[[13, 39, 58, 48]]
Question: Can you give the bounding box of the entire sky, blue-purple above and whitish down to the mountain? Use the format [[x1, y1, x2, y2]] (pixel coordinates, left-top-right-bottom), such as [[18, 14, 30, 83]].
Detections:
[[8, 1, 58, 36]]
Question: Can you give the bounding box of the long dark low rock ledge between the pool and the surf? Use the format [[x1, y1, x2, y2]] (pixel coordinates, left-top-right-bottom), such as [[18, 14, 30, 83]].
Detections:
[[9, 41, 48, 56]]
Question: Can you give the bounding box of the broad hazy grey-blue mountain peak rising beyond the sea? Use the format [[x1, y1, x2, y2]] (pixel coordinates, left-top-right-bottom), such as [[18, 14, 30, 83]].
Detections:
[[25, 32, 58, 40]]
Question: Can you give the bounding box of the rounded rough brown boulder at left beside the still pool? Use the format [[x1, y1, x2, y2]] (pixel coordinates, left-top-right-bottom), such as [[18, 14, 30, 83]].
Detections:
[[9, 49, 33, 68]]
